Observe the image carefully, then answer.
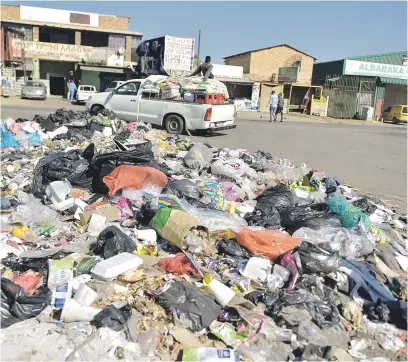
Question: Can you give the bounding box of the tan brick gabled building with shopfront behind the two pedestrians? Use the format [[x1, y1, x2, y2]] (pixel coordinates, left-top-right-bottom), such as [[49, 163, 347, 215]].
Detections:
[[224, 44, 320, 112]]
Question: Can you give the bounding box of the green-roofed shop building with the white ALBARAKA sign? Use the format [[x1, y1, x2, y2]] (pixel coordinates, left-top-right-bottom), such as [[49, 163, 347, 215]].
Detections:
[[313, 51, 408, 120]]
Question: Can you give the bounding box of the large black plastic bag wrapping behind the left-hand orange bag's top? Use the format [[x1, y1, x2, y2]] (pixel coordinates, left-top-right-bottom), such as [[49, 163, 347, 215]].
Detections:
[[91, 142, 159, 194]]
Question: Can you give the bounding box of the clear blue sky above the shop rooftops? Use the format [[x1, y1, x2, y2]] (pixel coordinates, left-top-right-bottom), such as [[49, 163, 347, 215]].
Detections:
[[2, 0, 407, 63]]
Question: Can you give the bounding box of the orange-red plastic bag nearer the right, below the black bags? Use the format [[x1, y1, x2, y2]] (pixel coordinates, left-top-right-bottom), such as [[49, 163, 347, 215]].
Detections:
[[237, 228, 300, 260]]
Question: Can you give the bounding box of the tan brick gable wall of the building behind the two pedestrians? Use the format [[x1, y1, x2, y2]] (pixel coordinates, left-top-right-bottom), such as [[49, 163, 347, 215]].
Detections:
[[250, 46, 314, 85]]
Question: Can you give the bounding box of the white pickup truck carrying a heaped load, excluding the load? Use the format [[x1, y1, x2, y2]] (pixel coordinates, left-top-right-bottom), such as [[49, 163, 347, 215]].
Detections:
[[86, 79, 236, 134]]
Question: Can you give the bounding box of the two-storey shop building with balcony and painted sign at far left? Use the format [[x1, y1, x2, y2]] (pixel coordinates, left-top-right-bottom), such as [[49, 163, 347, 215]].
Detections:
[[1, 5, 143, 96]]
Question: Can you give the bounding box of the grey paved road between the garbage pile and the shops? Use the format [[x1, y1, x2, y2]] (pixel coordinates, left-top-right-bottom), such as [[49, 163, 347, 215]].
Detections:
[[1, 103, 407, 209]]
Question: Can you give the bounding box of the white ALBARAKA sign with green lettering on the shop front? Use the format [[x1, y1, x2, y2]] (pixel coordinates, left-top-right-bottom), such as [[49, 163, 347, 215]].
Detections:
[[344, 60, 408, 79]]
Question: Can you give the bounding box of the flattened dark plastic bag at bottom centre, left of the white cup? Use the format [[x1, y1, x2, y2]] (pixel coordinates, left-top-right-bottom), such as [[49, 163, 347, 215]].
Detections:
[[156, 281, 221, 332]]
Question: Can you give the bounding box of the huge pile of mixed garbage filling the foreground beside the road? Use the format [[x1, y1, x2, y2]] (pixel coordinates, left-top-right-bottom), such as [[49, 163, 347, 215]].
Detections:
[[0, 111, 408, 361]]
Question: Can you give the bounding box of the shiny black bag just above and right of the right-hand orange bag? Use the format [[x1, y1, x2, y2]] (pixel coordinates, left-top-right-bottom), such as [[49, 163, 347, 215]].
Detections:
[[278, 203, 331, 227]]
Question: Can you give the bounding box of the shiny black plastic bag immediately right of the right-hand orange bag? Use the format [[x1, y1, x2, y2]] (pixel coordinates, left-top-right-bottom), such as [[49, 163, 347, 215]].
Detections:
[[299, 241, 340, 274]]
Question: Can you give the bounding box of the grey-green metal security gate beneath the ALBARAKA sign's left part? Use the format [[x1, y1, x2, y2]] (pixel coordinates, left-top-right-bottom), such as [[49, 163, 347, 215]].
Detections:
[[323, 75, 376, 119]]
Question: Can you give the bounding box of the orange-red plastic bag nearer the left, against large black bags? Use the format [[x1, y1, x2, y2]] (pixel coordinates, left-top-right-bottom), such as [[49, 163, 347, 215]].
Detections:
[[103, 166, 167, 196]]
